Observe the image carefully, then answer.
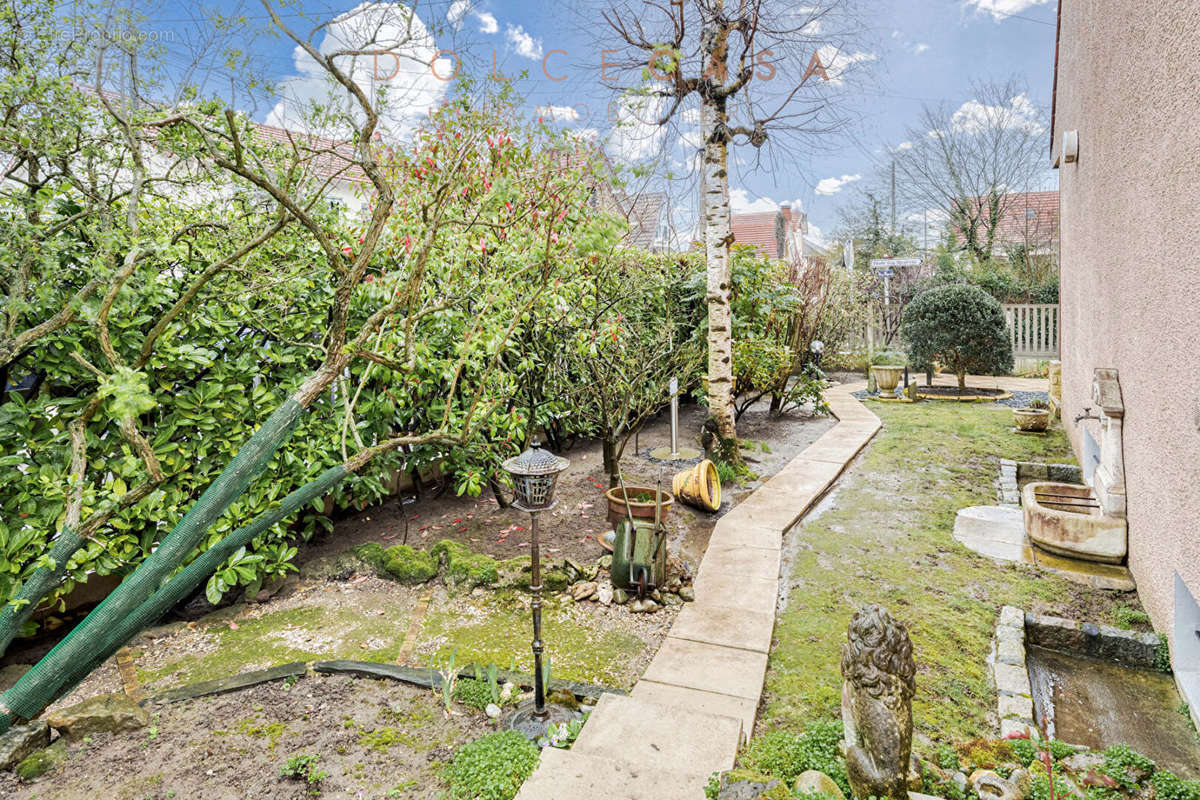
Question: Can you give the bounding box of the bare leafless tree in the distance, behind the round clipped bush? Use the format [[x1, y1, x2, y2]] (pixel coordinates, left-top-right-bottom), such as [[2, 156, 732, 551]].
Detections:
[[894, 79, 1045, 264]]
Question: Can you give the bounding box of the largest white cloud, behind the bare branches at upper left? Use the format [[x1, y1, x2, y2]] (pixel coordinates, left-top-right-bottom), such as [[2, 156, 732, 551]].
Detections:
[[265, 2, 456, 138]]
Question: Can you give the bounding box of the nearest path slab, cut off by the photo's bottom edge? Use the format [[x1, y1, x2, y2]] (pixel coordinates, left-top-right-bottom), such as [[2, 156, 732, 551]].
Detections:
[[516, 747, 708, 800]]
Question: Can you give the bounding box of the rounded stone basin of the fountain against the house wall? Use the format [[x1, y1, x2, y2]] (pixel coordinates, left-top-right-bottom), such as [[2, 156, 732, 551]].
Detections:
[[1021, 481, 1128, 564]]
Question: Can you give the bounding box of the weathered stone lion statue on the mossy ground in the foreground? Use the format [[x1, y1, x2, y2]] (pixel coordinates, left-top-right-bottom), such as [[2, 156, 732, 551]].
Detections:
[[841, 606, 917, 800]]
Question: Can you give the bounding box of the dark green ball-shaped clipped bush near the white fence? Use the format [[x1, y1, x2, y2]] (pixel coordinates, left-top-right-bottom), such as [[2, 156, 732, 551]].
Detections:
[[900, 283, 1013, 390]]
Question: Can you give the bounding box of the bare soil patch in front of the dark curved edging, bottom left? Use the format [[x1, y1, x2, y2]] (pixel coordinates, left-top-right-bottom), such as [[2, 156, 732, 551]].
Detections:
[[0, 675, 498, 800]]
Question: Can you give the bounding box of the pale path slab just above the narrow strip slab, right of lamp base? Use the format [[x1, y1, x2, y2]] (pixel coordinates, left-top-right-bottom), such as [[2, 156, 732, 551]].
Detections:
[[642, 636, 767, 702]]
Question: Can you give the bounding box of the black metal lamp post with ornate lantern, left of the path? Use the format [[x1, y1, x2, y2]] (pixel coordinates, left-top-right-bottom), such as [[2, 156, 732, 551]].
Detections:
[[502, 439, 571, 739]]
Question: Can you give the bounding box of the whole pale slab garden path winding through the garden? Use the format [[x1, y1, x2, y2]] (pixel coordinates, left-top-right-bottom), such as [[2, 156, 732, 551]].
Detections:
[[517, 383, 880, 800]]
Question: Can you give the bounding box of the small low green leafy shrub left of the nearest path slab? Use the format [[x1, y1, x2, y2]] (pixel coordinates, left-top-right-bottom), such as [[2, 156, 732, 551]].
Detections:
[[442, 730, 539, 800]]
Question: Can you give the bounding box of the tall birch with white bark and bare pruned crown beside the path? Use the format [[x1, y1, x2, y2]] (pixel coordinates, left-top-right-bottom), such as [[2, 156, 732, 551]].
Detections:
[[592, 0, 859, 463]]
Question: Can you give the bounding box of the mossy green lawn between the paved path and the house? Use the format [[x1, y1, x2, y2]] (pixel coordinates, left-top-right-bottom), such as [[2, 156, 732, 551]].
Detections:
[[760, 403, 1136, 742]]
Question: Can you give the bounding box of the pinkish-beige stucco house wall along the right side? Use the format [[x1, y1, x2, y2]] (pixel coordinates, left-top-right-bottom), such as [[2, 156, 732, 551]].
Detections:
[[1055, 0, 1200, 652]]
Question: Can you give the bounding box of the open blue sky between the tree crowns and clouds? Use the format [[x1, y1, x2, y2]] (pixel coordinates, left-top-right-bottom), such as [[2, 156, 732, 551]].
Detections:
[[152, 0, 1055, 244]]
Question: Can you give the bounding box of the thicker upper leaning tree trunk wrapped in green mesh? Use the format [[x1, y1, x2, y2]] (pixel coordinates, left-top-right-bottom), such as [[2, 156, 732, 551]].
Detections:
[[0, 397, 305, 732]]
